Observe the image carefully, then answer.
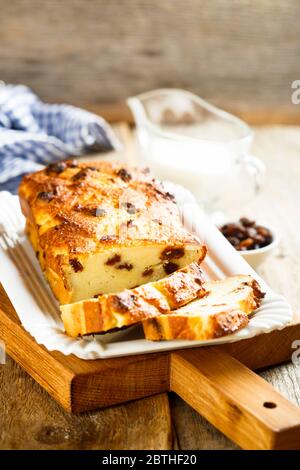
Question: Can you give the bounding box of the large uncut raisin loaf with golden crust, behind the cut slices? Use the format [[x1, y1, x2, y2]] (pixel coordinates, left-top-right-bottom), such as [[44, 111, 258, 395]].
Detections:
[[19, 161, 206, 304]]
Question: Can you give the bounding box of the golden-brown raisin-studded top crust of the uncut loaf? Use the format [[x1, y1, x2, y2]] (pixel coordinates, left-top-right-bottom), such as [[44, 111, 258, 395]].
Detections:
[[19, 162, 198, 253]]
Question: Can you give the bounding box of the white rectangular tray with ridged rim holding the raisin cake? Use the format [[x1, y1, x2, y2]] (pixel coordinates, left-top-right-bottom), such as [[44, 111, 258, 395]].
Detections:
[[0, 187, 292, 359]]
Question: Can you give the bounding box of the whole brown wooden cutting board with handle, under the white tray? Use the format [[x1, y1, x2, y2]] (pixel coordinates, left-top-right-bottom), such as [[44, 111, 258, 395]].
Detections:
[[0, 286, 300, 449]]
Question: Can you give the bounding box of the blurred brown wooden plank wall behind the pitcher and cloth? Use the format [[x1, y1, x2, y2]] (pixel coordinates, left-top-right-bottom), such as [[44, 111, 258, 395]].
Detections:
[[0, 0, 300, 123]]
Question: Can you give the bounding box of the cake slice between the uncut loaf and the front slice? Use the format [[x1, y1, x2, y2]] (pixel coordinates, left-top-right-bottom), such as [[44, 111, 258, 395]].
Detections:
[[60, 263, 206, 337]]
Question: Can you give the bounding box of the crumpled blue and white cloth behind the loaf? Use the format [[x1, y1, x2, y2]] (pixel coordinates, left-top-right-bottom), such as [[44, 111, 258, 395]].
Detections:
[[0, 85, 120, 193]]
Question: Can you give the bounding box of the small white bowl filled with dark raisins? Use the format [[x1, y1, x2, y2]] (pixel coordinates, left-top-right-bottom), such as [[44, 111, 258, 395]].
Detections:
[[219, 217, 279, 268]]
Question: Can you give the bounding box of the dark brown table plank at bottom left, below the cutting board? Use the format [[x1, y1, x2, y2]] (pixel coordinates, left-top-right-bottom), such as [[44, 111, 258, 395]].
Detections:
[[0, 357, 172, 450]]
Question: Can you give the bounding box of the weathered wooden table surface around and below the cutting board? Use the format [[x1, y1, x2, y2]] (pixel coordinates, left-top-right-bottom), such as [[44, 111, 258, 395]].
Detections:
[[0, 126, 300, 450]]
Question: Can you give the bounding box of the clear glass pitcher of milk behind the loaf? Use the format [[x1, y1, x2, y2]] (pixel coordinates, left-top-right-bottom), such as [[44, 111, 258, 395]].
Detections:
[[127, 89, 265, 211]]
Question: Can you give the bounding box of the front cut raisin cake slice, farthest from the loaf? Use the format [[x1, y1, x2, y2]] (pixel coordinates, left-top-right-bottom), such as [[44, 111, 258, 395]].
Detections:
[[143, 275, 264, 341]]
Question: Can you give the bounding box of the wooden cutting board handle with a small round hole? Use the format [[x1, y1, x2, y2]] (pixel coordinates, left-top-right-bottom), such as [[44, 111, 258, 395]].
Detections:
[[170, 347, 300, 450]]
